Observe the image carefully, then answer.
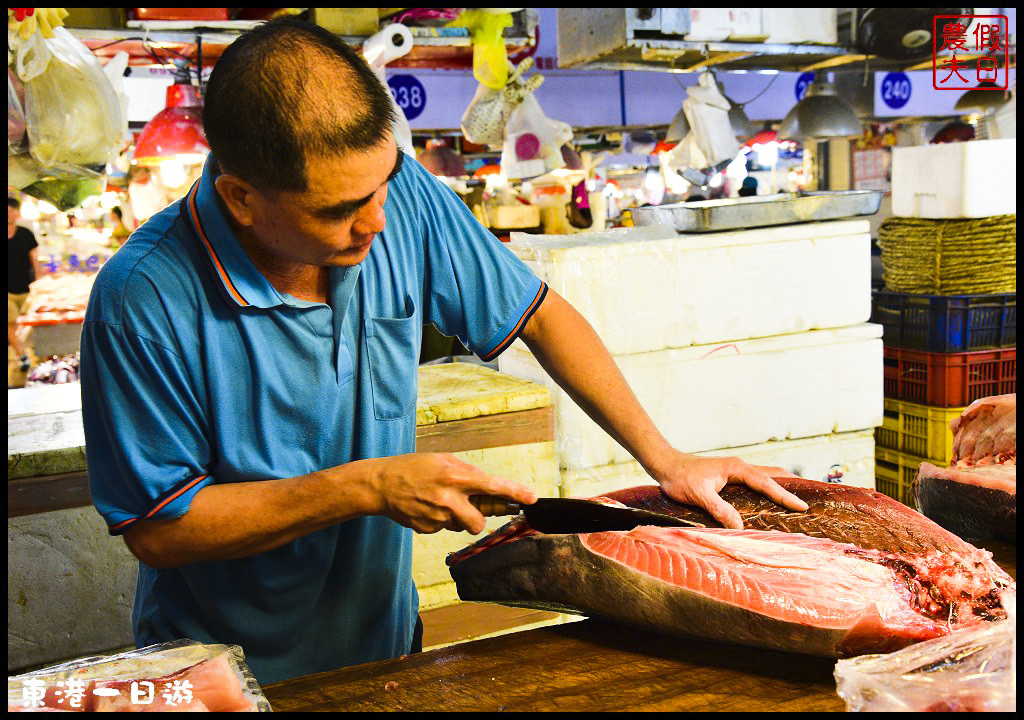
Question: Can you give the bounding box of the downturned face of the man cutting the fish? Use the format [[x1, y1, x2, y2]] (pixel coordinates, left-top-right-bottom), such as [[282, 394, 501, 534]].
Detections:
[[250, 138, 402, 266]]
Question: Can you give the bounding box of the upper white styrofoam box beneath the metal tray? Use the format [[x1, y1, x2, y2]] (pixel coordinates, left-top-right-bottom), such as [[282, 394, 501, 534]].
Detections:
[[510, 220, 871, 354]]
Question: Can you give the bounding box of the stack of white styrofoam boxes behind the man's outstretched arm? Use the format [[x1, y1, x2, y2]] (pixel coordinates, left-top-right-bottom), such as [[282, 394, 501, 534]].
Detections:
[[499, 220, 882, 497]]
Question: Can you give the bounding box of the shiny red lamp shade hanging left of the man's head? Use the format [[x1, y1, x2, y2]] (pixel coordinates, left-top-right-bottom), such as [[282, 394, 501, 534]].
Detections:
[[135, 84, 210, 165]]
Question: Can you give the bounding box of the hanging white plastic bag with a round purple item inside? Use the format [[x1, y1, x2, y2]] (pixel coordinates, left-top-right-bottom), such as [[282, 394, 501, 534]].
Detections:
[[501, 93, 572, 179]]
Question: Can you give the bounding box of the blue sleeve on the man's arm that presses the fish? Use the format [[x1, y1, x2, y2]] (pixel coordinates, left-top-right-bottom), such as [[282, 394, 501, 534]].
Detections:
[[413, 159, 547, 361]]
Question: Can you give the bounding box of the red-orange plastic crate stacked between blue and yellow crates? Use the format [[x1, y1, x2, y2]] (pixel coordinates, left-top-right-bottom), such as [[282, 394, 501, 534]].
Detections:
[[883, 347, 1017, 408]]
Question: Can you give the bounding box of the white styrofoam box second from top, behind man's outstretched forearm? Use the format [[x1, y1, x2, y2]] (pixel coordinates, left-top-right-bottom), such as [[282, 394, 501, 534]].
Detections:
[[498, 323, 883, 468]]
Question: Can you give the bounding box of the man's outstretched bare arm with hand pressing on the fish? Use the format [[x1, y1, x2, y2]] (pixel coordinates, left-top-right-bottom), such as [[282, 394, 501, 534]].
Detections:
[[520, 289, 807, 528]]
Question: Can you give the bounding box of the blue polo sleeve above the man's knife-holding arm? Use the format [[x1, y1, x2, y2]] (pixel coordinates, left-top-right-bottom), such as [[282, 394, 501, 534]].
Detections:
[[81, 321, 212, 535]]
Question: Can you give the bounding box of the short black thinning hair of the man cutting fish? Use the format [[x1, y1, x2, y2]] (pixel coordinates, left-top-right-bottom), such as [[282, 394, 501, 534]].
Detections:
[[203, 17, 394, 192]]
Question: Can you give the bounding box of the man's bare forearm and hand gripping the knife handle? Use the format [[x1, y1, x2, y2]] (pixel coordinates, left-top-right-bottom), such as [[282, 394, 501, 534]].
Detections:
[[125, 453, 536, 568]]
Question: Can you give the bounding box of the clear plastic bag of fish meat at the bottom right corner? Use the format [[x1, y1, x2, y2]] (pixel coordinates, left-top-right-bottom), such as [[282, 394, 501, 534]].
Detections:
[[835, 593, 1017, 712]]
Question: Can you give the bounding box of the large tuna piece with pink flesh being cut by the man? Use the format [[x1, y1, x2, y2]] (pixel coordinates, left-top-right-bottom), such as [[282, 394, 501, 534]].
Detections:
[[449, 478, 1014, 657]]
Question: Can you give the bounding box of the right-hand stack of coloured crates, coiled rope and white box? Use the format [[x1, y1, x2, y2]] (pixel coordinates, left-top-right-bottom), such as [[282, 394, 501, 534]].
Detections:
[[871, 139, 1017, 506]]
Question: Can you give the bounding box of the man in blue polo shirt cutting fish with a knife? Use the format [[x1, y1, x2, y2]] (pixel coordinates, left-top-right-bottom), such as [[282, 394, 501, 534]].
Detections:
[[82, 19, 806, 683]]
